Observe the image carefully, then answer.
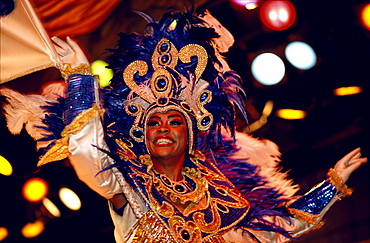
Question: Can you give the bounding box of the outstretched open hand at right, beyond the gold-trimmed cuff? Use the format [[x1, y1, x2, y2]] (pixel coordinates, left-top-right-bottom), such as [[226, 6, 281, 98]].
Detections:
[[334, 148, 367, 183]]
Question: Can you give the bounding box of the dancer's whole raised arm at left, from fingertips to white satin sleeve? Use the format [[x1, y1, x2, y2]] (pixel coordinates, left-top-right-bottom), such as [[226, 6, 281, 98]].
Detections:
[[45, 37, 125, 205]]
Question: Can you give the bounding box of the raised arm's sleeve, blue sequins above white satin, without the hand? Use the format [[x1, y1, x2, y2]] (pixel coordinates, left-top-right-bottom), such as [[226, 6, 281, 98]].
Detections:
[[63, 70, 121, 199]]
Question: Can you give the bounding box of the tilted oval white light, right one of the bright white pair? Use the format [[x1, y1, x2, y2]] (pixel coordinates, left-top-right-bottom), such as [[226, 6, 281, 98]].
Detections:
[[285, 41, 317, 70]]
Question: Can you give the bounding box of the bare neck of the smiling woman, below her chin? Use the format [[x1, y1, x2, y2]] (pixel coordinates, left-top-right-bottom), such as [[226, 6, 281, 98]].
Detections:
[[152, 156, 185, 181]]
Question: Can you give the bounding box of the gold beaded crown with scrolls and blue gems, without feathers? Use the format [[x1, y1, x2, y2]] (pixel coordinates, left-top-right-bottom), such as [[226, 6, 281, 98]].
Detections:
[[123, 38, 213, 144]]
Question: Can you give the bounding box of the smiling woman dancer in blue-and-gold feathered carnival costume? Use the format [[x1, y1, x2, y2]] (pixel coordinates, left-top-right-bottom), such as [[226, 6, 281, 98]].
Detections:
[[1, 8, 367, 242]]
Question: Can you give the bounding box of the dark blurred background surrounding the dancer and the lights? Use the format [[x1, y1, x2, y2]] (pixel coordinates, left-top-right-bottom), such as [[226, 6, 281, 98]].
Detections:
[[0, 0, 370, 243]]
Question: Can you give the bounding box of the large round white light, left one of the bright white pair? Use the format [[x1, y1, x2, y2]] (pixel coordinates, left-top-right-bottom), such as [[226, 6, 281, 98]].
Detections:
[[251, 53, 285, 85]]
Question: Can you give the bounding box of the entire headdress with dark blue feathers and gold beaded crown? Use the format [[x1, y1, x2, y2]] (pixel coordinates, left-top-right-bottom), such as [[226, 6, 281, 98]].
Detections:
[[104, 8, 244, 158]]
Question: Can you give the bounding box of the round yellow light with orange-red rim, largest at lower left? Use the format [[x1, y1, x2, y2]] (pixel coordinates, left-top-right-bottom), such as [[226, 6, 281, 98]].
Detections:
[[22, 178, 49, 202]]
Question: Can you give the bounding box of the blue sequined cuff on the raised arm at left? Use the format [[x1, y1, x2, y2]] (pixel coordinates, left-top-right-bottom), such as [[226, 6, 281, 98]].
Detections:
[[63, 74, 95, 125]]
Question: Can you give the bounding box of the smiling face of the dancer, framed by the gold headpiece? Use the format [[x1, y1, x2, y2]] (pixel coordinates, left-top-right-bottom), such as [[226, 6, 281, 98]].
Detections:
[[146, 110, 189, 162]]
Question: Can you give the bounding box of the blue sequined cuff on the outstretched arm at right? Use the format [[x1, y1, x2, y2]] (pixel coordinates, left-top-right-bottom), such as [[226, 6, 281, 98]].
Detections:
[[289, 181, 337, 214]]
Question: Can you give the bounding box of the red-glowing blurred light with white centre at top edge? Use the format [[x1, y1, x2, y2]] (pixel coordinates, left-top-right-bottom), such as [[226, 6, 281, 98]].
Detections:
[[260, 0, 296, 30]]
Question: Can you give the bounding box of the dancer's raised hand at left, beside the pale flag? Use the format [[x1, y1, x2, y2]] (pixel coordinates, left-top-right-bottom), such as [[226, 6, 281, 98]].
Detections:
[[51, 36, 89, 68]]
